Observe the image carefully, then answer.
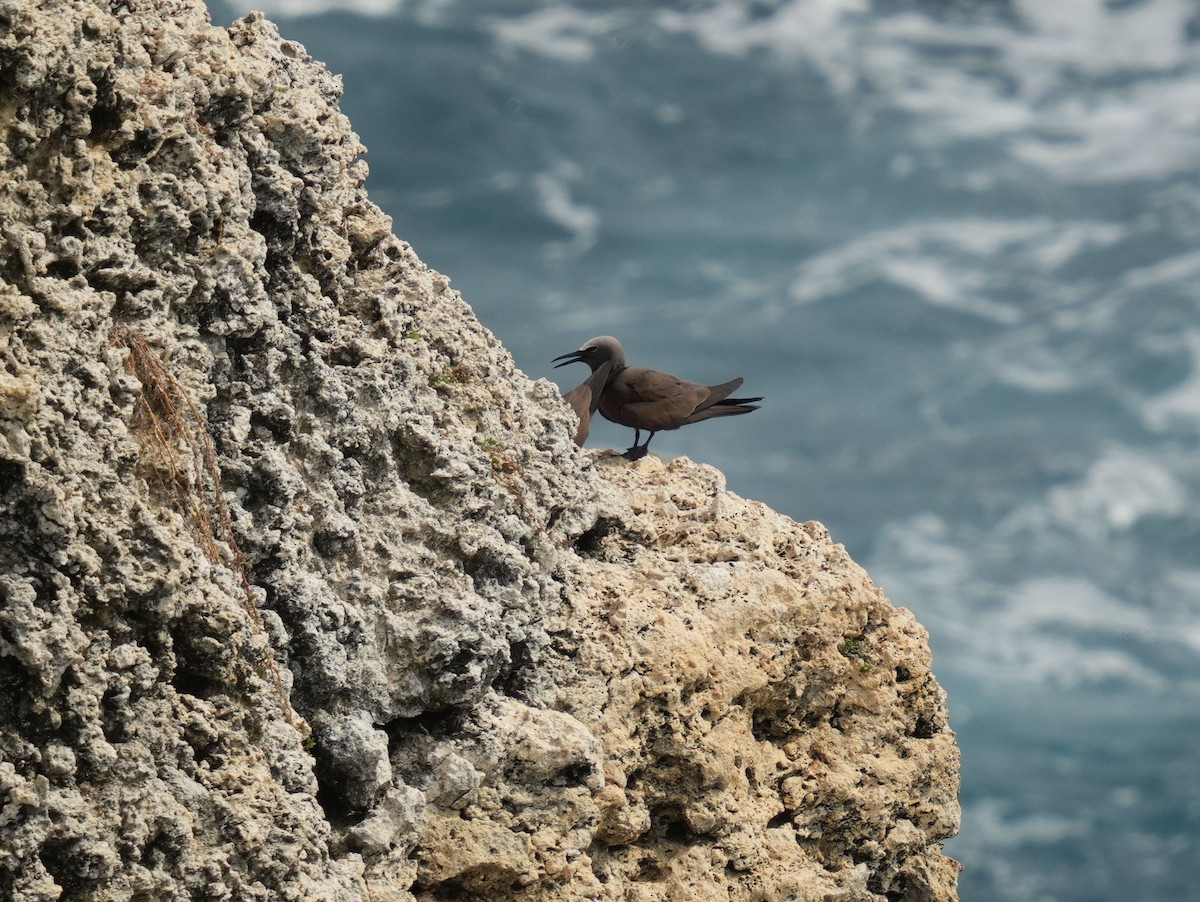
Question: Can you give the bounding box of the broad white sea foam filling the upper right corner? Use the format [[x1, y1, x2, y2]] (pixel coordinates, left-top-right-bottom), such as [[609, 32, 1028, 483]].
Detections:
[[659, 0, 1200, 187]]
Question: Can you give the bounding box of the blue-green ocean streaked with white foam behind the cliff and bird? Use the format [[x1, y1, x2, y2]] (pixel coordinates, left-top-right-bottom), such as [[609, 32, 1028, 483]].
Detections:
[[212, 0, 1200, 902]]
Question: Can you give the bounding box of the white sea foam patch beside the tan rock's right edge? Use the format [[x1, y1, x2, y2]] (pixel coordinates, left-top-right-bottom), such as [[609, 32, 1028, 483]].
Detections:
[[870, 513, 1200, 694]]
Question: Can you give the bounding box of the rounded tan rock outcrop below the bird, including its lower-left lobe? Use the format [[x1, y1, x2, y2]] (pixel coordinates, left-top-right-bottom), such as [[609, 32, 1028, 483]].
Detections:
[[379, 452, 959, 902]]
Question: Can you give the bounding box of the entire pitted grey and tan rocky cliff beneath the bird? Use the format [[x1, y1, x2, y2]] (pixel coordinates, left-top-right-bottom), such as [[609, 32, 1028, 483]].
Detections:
[[0, 0, 958, 902]]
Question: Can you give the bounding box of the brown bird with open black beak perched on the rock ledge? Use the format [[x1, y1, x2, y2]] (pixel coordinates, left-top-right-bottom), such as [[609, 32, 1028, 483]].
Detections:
[[552, 335, 762, 461]]
